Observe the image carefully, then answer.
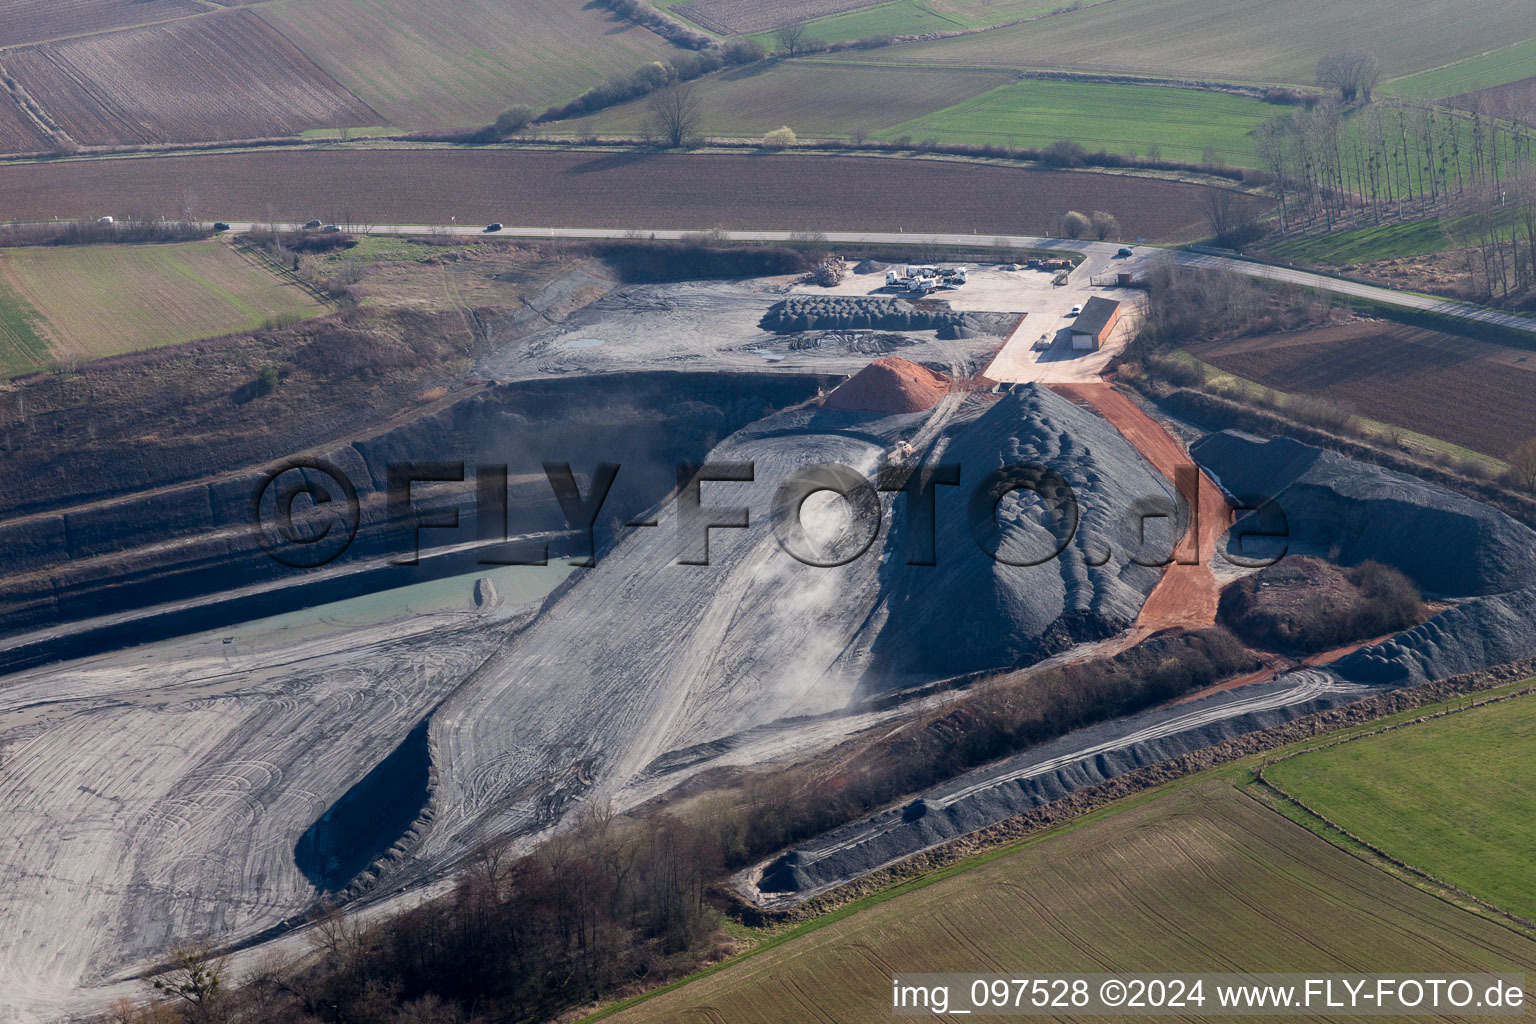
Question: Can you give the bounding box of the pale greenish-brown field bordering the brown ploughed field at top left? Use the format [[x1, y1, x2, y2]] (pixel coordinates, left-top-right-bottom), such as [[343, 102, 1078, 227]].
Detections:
[[252, 0, 677, 127]]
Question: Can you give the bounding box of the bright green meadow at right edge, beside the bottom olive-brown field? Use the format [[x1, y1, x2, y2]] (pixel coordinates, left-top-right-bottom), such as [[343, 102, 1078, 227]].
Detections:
[[1266, 697, 1536, 920]]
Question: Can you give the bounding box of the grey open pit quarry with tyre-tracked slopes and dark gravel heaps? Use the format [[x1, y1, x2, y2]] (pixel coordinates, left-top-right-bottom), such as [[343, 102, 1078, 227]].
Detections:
[[0, 262, 1536, 1022]]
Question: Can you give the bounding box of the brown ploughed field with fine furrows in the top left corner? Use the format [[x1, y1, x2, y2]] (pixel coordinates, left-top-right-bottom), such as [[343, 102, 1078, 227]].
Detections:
[[6, 11, 382, 146]]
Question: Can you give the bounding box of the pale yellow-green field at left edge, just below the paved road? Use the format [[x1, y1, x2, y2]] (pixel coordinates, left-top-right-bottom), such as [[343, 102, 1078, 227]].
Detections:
[[0, 241, 324, 375]]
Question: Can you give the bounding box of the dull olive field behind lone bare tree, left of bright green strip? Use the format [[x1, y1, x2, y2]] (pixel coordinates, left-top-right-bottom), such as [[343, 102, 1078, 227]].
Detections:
[[558, 60, 1011, 138]]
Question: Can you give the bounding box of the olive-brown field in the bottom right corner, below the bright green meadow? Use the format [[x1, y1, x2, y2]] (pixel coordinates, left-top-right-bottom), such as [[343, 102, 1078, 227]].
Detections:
[[610, 778, 1536, 1024]]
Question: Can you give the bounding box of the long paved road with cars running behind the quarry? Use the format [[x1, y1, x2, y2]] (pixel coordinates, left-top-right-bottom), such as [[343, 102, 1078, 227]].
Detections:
[[232, 223, 1536, 335]]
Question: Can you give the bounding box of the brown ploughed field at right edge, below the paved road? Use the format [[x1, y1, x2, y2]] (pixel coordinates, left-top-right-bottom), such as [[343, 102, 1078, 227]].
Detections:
[[1189, 321, 1536, 457]]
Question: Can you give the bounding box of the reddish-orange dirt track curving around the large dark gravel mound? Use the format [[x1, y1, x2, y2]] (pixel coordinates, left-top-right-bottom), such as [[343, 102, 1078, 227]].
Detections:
[[1049, 381, 1232, 634]]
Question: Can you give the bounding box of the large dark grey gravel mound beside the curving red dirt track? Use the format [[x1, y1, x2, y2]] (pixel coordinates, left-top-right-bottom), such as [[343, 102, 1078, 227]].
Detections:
[[872, 385, 1169, 682]]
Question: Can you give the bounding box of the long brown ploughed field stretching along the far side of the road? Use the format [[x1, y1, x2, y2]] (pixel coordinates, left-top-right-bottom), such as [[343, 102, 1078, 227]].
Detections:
[[0, 150, 1247, 239]]
